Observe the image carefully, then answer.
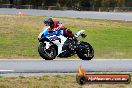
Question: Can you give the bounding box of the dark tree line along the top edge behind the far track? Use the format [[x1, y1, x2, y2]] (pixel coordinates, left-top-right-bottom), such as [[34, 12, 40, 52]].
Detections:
[[0, 0, 132, 8]]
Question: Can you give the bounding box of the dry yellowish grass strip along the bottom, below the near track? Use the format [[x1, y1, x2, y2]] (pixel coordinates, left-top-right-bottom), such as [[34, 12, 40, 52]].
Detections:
[[0, 73, 132, 88]]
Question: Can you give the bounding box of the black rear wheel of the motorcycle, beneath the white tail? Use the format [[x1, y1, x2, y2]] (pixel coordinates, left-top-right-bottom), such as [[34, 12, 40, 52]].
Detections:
[[77, 42, 94, 60]]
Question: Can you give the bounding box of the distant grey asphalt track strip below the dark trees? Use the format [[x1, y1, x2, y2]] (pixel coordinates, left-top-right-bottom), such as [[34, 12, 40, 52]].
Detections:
[[0, 8, 132, 21]]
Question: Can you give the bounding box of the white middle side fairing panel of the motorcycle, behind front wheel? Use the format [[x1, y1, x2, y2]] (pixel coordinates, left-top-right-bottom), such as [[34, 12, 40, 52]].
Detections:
[[52, 35, 67, 55]]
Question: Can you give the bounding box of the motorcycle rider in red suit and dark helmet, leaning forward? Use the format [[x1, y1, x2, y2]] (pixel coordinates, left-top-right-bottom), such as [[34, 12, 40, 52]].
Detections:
[[44, 18, 76, 40]]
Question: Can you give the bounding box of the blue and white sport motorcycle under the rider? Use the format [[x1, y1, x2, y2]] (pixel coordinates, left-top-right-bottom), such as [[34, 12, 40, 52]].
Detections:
[[38, 27, 94, 60]]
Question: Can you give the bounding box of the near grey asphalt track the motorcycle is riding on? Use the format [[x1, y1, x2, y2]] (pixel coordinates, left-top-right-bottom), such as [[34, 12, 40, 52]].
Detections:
[[0, 59, 132, 74]]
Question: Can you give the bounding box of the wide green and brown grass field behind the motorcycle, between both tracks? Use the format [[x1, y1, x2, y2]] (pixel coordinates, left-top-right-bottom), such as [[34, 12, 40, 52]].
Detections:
[[0, 15, 132, 59]]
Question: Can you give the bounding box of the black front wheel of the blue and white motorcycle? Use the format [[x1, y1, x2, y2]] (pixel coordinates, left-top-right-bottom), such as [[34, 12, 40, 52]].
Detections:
[[38, 43, 57, 60]]
